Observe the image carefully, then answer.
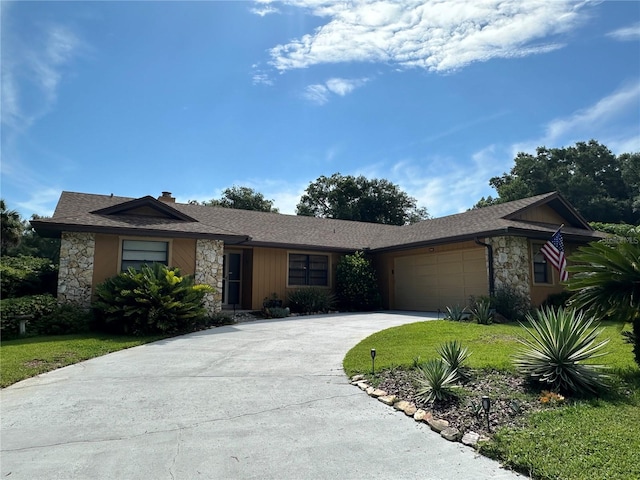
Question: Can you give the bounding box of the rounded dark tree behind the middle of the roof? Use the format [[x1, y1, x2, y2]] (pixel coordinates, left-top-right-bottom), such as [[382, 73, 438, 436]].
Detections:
[[296, 173, 428, 225]]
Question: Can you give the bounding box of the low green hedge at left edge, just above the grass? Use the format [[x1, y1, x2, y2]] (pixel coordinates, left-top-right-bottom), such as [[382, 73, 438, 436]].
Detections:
[[0, 294, 58, 339]]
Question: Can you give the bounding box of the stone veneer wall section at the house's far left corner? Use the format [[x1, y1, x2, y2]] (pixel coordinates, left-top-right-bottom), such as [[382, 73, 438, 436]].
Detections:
[[58, 232, 95, 308]]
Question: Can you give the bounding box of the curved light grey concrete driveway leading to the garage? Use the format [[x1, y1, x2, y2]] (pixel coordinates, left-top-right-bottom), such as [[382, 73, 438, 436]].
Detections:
[[0, 313, 519, 480]]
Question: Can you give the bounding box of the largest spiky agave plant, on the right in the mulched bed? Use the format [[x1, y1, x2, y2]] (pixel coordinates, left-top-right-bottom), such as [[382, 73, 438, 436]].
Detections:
[[514, 308, 609, 393]]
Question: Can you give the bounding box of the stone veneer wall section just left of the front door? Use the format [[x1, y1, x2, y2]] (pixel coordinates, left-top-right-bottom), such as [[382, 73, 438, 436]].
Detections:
[[195, 239, 224, 314]]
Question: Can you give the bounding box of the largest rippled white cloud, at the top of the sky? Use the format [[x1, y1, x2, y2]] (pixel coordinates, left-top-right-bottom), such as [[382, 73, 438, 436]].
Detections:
[[258, 0, 584, 72]]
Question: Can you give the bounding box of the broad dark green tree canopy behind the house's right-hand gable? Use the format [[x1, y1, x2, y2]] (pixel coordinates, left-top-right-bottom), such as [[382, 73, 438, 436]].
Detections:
[[474, 140, 640, 224]]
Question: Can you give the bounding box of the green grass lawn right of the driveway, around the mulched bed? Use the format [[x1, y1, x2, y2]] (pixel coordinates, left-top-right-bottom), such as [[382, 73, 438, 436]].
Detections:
[[344, 321, 640, 480]]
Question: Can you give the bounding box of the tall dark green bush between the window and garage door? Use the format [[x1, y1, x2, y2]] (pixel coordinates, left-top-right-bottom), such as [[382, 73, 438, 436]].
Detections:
[[336, 252, 382, 311]]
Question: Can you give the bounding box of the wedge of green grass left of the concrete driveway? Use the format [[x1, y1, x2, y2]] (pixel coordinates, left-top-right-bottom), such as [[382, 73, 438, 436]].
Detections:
[[0, 333, 164, 388]]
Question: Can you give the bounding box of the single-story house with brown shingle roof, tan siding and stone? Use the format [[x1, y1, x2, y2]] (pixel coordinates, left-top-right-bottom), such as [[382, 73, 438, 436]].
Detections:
[[31, 192, 602, 312]]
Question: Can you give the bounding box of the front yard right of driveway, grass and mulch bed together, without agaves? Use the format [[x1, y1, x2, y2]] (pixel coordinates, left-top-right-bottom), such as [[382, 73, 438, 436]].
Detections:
[[344, 320, 640, 480]]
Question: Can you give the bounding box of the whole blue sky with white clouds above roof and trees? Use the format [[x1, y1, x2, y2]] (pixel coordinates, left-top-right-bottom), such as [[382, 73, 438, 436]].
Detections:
[[0, 0, 640, 218]]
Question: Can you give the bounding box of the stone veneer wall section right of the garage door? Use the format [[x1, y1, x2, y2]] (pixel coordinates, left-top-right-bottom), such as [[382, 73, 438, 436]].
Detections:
[[487, 237, 531, 301]]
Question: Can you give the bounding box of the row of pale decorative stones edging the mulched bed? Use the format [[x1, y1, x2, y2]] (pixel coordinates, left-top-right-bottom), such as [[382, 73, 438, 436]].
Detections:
[[351, 375, 489, 449]]
